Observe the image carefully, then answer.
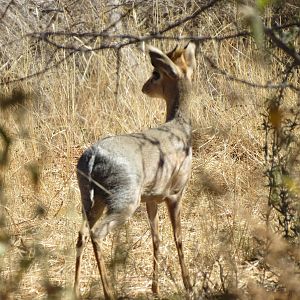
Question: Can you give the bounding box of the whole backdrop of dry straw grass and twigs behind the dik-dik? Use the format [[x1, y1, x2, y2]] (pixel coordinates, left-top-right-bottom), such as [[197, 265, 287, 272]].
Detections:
[[0, 0, 300, 299]]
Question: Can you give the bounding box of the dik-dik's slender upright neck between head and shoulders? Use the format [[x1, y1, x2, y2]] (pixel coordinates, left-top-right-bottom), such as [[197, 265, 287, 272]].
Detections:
[[166, 80, 192, 126]]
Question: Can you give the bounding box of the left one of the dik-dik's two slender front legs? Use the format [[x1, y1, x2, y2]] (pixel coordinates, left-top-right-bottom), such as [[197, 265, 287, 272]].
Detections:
[[146, 202, 160, 294]]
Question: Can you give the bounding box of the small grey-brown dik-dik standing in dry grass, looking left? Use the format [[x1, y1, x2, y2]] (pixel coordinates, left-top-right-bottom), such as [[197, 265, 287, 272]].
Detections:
[[74, 43, 196, 299]]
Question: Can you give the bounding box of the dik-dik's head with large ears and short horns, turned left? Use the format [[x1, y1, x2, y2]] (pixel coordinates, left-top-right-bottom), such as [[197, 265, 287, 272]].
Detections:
[[142, 43, 196, 100]]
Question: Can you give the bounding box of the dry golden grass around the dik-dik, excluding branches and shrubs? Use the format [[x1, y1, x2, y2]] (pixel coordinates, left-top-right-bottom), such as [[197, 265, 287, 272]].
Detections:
[[0, 1, 300, 299]]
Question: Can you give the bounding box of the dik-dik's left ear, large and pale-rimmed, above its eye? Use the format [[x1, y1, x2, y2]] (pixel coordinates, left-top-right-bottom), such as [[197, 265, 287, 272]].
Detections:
[[148, 46, 180, 79]]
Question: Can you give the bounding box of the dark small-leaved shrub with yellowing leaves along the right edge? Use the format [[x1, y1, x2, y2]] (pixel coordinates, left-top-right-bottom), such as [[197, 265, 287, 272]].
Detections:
[[263, 62, 300, 239]]
